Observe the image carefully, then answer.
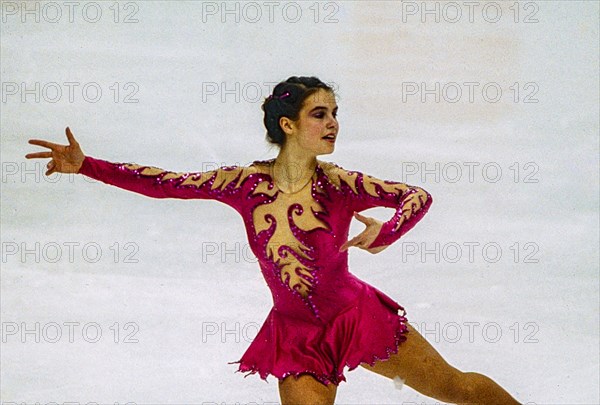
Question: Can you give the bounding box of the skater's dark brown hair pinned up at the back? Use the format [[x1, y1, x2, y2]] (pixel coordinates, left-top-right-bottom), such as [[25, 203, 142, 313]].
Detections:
[[261, 76, 334, 147]]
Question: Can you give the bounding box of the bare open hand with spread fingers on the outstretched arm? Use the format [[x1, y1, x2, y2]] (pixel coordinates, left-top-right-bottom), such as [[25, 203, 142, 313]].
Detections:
[[25, 127, 85, 176]]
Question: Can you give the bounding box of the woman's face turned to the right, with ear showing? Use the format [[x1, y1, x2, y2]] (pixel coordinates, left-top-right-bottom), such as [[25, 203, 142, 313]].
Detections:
[[281, 89, 339, 156]]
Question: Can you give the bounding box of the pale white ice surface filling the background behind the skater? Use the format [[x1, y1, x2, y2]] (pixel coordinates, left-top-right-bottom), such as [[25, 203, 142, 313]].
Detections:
[[0, 1, 600, 404]]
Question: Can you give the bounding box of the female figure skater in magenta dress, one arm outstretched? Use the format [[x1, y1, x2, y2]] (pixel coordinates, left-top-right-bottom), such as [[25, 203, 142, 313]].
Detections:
[[26, 76, 518, 405]]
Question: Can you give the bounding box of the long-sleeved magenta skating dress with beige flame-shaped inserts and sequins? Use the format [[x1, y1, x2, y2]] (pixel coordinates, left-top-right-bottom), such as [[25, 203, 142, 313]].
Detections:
[[79, 156, 432, 385]]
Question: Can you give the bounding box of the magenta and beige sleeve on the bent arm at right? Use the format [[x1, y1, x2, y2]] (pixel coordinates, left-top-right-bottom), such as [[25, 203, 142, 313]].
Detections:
[[332, 163, 433, 248]]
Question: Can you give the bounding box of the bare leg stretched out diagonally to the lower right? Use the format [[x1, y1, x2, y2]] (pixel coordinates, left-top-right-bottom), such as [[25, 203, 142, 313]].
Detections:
[[361, 324, 519, 405]]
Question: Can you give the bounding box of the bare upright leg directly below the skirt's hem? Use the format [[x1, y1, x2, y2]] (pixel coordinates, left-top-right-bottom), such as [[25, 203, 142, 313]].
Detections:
[[279, 374, 337, 405]]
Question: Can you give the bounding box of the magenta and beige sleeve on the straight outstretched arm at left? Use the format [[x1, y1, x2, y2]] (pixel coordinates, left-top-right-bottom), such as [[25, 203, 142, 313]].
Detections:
[[78, 156, 247, 210]]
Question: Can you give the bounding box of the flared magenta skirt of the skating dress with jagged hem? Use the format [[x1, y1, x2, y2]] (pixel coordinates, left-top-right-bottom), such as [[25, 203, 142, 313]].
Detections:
[[228, 287, 408, 385]]
